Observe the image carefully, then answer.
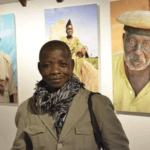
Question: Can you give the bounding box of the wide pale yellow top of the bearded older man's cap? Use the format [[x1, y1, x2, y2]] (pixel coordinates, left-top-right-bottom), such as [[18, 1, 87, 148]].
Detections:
[[116, 10, 150, 29]]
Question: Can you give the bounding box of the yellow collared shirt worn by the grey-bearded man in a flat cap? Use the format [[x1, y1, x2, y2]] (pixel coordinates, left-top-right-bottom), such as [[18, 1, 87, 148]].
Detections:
[[113, 52, 150, 113]]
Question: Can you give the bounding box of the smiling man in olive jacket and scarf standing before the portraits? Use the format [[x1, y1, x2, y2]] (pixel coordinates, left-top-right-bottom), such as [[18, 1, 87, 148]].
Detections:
[[12, 41, 129, 150]]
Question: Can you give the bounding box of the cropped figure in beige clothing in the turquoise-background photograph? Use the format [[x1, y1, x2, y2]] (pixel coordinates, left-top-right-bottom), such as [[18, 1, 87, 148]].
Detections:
[[0, 51, 17, 103]]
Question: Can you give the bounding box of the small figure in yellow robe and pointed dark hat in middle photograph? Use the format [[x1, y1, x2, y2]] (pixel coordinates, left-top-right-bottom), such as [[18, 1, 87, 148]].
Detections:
[[61, 19, 89, 78]]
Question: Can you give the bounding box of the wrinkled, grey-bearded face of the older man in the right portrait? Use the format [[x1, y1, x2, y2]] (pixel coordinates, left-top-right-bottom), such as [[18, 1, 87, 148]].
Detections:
[[124, 33, 150, 71]]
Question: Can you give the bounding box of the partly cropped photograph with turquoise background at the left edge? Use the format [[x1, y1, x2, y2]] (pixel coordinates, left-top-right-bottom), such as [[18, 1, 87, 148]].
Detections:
[[0, 14, 17, 104]]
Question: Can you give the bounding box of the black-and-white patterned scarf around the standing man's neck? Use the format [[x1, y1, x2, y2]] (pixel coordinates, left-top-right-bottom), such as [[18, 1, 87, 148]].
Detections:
[[33, 75, 84, 134]]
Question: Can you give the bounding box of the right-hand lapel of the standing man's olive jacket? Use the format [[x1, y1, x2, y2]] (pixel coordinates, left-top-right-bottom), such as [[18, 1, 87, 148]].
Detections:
[[59, 89, 89, 140]]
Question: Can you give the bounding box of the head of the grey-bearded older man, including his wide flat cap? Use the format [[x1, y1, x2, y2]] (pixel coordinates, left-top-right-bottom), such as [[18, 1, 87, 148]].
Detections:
[[117, 11, 150, 71]]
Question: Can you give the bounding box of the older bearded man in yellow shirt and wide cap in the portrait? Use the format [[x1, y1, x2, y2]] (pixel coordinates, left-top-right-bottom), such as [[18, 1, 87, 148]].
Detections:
[[113, 11, 150, 113]]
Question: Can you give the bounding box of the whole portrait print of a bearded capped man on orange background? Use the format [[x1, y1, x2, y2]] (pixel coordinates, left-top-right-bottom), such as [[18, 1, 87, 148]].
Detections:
[[111, 0, 150, 115]]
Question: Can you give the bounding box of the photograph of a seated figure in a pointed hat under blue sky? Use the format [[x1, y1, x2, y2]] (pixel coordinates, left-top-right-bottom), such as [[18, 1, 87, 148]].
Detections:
[[45, 4, 98, 92]]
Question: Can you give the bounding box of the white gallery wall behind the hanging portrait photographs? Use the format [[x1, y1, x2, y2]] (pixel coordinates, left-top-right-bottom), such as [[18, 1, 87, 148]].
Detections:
[[0, 0, 150, 150]]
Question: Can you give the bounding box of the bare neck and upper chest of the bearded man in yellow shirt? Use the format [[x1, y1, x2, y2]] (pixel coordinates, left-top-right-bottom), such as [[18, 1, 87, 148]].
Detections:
[[124, 63, 150, 96]]
